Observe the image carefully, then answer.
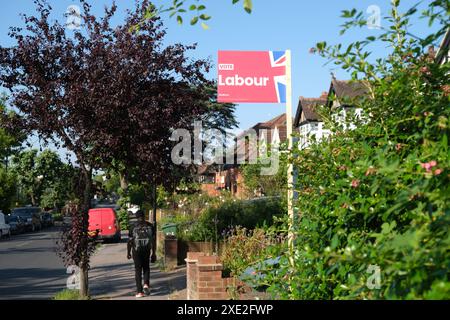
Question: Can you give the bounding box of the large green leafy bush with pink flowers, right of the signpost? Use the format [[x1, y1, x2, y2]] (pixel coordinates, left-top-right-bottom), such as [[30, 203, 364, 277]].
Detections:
[[246, 2, 450, 299]]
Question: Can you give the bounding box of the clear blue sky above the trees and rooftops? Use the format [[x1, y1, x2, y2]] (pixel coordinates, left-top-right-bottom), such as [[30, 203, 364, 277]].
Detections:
[[0, 0, 440, 134]]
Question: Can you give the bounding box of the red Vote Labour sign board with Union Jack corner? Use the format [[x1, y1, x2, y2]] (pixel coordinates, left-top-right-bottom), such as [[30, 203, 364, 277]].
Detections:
[[218, 51, 286, 103]]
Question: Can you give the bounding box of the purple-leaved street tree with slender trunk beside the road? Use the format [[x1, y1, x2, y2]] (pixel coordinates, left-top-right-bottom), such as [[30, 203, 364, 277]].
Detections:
[[0, 0, 234, 296]]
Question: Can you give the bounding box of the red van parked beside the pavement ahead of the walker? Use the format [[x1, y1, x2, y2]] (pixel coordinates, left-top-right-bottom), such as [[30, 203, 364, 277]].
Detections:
[[88, 208, 121, 242]]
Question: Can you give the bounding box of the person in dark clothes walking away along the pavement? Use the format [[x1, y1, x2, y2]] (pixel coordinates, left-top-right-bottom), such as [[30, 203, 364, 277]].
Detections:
[[127, 210, 156, 298]]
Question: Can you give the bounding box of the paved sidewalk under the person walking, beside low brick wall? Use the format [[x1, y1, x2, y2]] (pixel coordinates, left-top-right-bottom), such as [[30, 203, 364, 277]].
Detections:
[[89, 240, 186, 300]]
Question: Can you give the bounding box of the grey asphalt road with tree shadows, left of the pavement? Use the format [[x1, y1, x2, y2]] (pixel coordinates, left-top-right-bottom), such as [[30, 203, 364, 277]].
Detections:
[[0, 228, 68, 300]]
